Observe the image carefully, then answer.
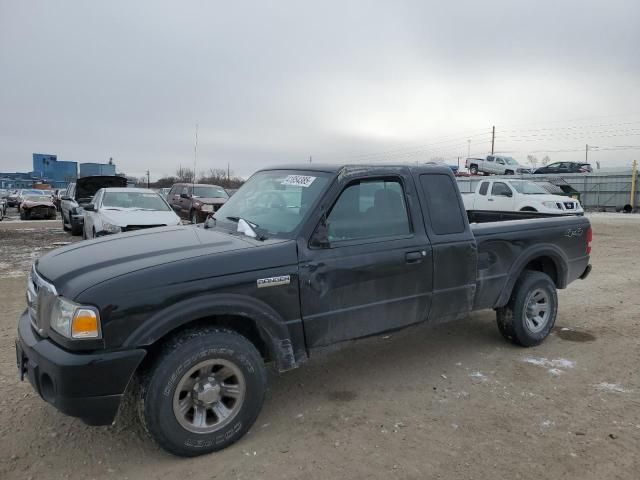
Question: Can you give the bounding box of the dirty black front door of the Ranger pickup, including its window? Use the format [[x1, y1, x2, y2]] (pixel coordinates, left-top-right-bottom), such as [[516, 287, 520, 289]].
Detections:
[[299, 170, 432, 347]]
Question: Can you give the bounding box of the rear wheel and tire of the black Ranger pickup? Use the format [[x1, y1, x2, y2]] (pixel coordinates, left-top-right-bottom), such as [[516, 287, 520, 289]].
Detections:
[[496, 271, 558, 347]]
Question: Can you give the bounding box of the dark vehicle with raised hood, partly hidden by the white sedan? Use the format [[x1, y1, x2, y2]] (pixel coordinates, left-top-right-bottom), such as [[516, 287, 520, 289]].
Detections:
[[60, 175, 127, 235]]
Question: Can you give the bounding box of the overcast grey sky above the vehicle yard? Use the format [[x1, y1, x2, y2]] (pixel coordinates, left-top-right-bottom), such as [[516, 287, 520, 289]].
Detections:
[[0, 0, 640, 178]]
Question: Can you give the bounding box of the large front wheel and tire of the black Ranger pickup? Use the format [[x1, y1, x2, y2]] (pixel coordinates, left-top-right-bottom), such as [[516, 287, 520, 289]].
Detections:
[[138, 328, 267, 457]]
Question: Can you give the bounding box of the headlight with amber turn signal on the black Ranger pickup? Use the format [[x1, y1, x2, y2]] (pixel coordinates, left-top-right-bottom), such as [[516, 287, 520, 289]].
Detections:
[[50, 297, 100, 339]]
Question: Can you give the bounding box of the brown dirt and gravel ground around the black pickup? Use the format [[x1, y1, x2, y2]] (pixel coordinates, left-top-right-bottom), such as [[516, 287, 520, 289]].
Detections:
[[0, 214, 640, 480]]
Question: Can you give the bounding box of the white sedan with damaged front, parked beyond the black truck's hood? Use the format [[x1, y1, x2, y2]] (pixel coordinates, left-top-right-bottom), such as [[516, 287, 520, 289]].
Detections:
[[82, 188, 182, 238]]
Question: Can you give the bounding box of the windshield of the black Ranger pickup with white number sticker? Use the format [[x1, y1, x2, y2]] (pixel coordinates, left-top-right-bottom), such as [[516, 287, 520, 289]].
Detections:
[[213, 170, 330, 238]]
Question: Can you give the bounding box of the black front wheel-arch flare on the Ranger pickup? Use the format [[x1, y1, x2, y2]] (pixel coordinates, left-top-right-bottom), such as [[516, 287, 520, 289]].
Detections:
[[124, 293, 306, 371]]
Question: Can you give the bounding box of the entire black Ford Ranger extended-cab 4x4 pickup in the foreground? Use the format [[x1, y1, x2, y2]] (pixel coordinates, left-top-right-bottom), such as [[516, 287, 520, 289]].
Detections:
[[16, 165, 591, 456]]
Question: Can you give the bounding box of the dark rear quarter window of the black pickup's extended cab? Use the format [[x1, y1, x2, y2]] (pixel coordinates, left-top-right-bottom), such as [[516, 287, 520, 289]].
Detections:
[[420, 174, 465, 235]]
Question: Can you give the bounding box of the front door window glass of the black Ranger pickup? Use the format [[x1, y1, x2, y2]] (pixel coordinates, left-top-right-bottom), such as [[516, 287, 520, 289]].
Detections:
[[327, 179, 411, 242]]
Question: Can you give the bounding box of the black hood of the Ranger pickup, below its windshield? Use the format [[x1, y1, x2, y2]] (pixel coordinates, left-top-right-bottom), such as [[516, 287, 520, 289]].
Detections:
[[36, 225, 295, 299]]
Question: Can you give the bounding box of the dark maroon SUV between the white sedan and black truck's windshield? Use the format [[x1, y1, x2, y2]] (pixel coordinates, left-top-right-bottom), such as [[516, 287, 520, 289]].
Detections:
[[167, 183, 229, 223]]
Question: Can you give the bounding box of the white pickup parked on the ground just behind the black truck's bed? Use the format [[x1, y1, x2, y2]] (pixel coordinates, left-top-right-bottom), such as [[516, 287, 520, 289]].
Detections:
[[462, 178, 584, 215]]
